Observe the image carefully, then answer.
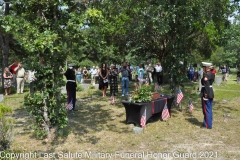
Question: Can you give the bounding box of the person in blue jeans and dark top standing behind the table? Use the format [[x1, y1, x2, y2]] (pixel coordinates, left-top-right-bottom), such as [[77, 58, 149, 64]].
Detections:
[[119, 62, 131, 97]]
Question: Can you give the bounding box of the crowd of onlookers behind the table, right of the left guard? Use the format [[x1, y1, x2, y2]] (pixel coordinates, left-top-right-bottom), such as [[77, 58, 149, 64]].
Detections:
[[62, 61, 163, 100]]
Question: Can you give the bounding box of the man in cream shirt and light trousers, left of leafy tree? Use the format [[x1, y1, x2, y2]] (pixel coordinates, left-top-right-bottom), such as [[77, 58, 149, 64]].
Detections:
[[14, 62, 26, 94]]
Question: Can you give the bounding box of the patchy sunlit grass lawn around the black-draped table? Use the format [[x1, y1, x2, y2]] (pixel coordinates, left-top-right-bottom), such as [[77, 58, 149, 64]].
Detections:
[[3, 74, 240, 159]]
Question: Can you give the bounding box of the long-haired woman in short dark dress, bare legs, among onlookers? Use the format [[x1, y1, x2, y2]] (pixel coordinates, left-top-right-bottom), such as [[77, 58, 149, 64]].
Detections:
[[99, 63, 109, 97]]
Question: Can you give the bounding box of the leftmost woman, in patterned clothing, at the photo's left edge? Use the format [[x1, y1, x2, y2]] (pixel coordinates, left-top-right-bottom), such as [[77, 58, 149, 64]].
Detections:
[[3, 67, 13, 96]]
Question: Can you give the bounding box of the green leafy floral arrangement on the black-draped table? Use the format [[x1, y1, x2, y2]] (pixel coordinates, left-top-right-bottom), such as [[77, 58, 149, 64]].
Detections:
[[130, 79, 152, 103]]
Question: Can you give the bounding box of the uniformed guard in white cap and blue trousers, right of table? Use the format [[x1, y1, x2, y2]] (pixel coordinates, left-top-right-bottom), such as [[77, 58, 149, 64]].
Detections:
[[201, 62, 214, 129]]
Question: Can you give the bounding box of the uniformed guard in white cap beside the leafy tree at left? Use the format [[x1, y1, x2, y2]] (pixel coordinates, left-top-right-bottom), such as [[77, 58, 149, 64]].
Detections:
[[64, 63, 77, 111]]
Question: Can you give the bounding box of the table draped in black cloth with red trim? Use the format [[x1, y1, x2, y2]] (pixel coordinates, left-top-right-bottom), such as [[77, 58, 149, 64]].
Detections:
[[122, 95, 174, 126]]
